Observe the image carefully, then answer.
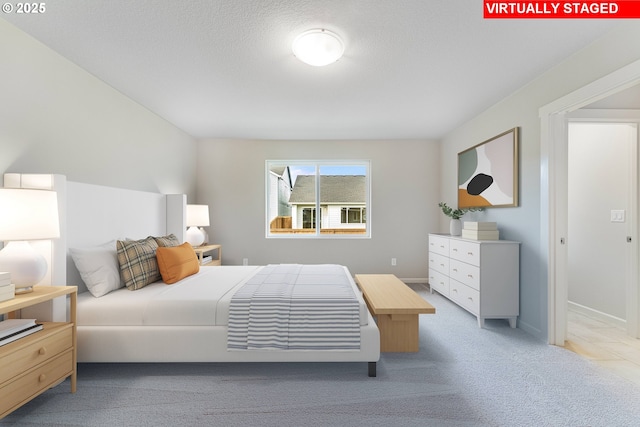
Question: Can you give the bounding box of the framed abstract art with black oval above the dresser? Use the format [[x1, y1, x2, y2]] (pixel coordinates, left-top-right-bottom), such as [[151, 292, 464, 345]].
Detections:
[[458, 127, 518, 209]]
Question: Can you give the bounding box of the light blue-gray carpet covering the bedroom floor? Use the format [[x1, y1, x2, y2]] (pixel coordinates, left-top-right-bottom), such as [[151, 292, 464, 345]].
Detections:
[[0, 285, 640, 427]]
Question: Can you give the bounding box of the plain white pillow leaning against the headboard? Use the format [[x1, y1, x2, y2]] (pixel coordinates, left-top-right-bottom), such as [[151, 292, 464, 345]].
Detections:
[[69, 240, 123, 297]]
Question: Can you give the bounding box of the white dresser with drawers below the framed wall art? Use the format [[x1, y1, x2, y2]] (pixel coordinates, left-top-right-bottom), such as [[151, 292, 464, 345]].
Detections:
[[429, 234, 520, 328]]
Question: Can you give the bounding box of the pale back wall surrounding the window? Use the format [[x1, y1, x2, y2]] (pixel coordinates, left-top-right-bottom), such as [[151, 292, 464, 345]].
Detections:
[[197, 140, 442, 280]]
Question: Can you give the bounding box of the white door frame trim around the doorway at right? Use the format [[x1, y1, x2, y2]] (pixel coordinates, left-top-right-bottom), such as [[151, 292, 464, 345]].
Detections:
[[539, 60, 640, 346]]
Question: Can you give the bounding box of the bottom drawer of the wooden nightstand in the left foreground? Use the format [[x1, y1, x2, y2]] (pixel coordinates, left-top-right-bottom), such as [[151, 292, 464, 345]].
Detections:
[[0, 349, 73, 414]]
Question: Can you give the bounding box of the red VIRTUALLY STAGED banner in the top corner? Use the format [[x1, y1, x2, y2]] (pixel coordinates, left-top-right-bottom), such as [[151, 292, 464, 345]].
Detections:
[[484, 0, 640, 19]]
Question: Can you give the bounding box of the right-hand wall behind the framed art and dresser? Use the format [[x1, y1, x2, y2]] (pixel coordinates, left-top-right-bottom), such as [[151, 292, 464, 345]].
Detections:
[[441, 21, 640, 340]]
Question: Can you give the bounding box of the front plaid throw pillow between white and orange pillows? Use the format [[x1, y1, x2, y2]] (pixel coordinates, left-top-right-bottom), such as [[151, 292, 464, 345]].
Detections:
[[116, 236, 162, 291]]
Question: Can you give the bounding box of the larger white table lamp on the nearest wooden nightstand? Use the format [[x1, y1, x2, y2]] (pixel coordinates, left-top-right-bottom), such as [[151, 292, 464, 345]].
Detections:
[[0, 188, 60, 294]]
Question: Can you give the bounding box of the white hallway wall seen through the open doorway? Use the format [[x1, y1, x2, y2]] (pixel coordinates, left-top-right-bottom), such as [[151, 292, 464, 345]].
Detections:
[[568, 123, 636, 319]]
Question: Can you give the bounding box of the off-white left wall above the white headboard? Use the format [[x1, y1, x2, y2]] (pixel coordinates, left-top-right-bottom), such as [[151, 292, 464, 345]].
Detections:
[[0, 19, 196, 195]]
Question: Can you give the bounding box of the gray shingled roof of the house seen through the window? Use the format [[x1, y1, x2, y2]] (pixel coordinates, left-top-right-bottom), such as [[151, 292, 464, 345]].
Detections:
[[289, 175, 367, 205]]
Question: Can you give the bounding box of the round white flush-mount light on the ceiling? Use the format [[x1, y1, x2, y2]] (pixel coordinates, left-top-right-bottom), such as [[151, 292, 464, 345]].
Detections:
[[292, 28, 344, 67]]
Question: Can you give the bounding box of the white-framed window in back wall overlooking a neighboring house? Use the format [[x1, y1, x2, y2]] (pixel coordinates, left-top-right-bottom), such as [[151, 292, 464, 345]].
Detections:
[[266, 160, 371, 238]]
